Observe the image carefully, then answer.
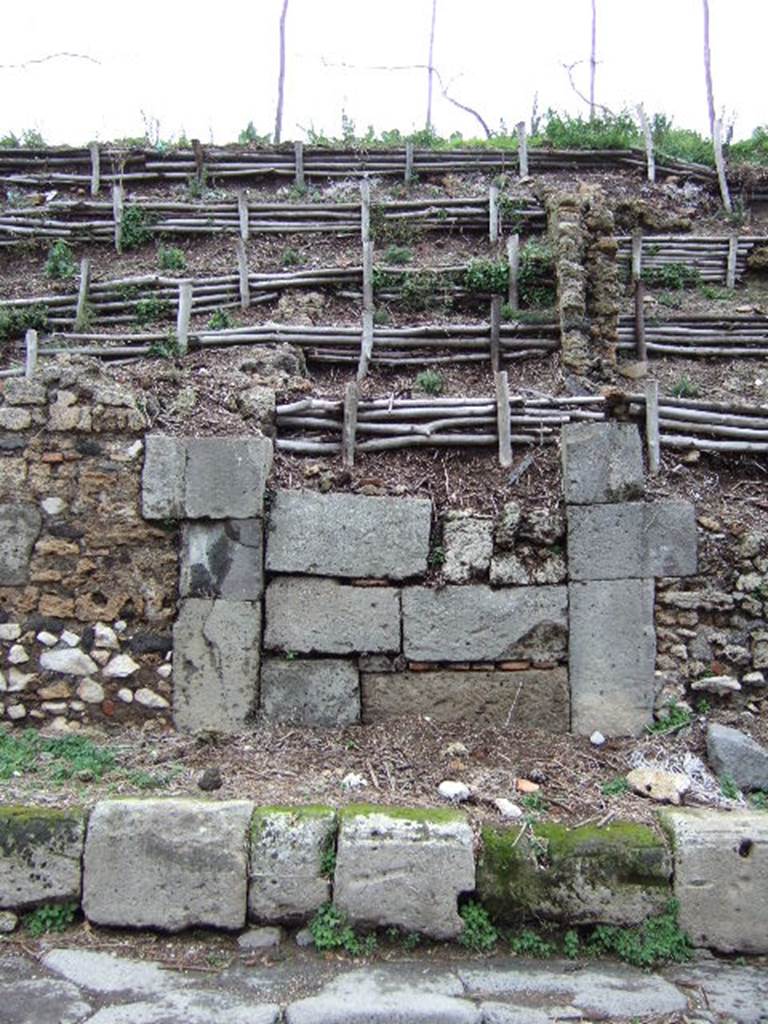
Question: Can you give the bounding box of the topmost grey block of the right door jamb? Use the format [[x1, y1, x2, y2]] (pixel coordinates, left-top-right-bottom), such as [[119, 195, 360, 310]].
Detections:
[[560, 422, 644, 505]]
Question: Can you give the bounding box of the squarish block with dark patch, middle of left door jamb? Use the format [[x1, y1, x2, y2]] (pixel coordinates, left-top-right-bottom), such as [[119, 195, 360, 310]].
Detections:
[[179, 519, 264, 601]]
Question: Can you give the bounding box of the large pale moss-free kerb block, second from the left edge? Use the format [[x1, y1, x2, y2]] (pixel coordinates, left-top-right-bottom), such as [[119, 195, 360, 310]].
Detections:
[[83, 798, 253, 932]]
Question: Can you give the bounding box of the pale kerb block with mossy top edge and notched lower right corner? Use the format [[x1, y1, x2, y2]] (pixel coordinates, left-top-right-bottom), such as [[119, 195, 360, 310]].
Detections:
[[334, 807, 475, 939]]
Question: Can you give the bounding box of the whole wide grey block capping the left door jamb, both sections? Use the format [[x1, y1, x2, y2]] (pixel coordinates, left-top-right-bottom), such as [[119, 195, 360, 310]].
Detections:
[[141, 434, 272, 519]]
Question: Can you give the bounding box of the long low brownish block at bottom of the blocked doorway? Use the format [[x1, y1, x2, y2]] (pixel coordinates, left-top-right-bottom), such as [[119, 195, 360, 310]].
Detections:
[[361, 669, 570, 732]]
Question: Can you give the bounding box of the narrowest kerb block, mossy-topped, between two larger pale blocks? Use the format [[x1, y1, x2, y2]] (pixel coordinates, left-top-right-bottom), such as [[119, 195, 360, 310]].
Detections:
[[248, 807, 336, 924]]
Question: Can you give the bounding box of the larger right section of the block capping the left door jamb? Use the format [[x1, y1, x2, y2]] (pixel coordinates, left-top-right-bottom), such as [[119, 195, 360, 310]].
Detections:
[[184, 437, 272, 519]]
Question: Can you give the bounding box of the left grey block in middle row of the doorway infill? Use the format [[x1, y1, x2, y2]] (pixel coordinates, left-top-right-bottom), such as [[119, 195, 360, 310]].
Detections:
[[264, 577, 400, 654]]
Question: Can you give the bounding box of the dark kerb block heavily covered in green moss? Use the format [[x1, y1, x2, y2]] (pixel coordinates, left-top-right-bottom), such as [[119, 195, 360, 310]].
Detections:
[[477, 822, 672, 927]]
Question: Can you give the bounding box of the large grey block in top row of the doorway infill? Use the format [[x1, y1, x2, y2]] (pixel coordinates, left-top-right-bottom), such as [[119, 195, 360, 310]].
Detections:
[[266, 490, 432, 580]]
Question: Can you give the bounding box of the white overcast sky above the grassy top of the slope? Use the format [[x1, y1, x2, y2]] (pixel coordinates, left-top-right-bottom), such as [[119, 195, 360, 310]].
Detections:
[[0, 0, 768, 144]]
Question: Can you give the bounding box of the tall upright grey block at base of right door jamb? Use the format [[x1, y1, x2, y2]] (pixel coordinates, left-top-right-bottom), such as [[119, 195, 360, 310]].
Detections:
[[568, 580, 656, 736]]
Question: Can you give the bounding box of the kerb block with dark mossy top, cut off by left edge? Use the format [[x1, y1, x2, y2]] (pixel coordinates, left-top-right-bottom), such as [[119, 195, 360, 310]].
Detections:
[[0, 807, 85, 910]]
